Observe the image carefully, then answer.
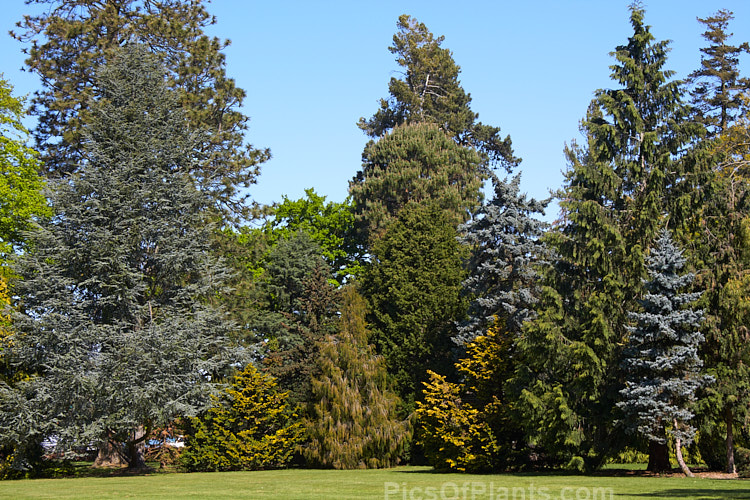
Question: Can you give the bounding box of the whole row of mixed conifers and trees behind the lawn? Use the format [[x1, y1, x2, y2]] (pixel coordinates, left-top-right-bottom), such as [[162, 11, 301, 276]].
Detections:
[[0, 0, 750, 477]]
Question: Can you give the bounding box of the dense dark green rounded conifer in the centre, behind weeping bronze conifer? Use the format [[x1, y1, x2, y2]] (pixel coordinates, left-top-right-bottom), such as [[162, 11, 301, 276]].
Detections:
[[362, 203, 466, 413]]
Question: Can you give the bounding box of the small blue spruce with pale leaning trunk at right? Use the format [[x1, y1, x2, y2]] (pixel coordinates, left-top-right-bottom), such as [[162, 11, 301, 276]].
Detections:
[[617, 230, 705, 476]]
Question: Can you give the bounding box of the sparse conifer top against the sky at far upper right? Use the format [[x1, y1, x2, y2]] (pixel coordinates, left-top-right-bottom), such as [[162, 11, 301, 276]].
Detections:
[[689, 9, 750, 133]]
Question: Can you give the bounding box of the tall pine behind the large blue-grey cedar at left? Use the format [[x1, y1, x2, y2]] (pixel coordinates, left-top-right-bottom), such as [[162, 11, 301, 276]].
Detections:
[[13, 0, 269, 219]]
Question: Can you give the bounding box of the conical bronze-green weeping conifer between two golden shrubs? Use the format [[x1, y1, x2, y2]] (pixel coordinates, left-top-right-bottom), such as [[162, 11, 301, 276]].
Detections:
[[303, 286, 410, 469]]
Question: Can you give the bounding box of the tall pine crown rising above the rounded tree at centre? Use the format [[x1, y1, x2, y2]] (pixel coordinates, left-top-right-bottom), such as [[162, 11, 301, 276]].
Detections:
[[359, 15, 520, 171]]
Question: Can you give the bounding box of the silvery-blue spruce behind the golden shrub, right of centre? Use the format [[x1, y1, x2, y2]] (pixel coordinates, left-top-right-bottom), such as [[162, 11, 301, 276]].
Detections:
[[454, 174, 547, 344]]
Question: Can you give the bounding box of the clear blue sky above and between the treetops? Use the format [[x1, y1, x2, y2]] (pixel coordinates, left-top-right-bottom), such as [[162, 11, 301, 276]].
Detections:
[[0, 0, 750, 218]]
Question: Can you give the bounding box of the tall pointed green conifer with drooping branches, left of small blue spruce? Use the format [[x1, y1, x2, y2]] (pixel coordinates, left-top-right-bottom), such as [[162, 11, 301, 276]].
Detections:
[[516, 4, 703, 468]]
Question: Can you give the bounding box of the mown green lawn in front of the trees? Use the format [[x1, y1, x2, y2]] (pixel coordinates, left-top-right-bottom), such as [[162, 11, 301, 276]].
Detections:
[[0, 467, 750, 500]]
